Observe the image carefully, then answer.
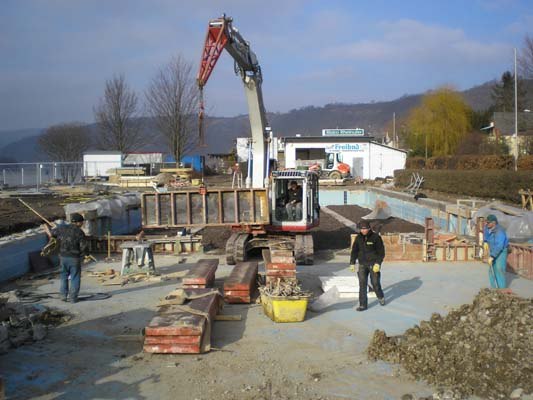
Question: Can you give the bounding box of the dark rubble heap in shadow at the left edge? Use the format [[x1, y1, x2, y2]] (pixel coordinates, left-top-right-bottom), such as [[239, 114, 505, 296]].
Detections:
[[0, 296, 71, 354]]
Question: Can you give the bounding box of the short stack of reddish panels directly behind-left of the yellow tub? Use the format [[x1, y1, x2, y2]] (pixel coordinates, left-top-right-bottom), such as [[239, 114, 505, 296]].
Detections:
[[224, 261, 257, 304]]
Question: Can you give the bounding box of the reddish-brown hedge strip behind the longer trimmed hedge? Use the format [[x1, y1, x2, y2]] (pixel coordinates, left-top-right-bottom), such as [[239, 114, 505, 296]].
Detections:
[[405, 155, 533, 171]]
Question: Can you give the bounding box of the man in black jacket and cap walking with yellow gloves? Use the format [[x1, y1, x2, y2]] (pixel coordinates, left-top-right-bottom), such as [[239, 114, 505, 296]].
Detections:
[[350, 221, 385, 311]]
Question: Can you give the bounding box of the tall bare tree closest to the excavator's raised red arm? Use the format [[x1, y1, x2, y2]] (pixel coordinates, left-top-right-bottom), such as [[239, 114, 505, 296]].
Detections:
[[145, 56, 199, 162]]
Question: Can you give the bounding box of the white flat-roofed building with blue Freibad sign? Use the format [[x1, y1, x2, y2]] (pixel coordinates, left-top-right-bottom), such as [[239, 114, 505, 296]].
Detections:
[[284, 135, 407, 179]]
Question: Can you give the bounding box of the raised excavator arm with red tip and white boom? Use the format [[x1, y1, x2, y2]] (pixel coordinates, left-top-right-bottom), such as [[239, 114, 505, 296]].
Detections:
[[197, 15, 269, 188]]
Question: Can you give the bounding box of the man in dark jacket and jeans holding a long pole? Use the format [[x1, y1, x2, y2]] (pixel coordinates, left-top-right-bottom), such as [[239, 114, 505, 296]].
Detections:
[[43, 213, 89, 303]]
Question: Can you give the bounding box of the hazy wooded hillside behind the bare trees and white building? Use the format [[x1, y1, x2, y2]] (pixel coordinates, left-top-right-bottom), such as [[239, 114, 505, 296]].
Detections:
[[0, 80, 533, 162]]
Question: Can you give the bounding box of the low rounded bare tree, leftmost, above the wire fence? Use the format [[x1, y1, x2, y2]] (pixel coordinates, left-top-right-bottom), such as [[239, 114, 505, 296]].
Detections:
[[39, 122, 91, 162]]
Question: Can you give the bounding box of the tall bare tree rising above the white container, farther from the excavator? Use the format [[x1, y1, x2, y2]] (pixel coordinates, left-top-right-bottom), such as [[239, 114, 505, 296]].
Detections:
[[94, 75, 144, 155]]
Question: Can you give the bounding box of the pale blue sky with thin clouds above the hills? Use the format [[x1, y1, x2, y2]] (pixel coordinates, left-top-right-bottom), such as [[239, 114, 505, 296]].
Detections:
[[0, 0, 533, 130]]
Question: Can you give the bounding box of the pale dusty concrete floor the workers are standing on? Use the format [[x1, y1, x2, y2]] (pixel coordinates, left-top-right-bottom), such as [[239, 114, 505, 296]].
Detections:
[[0, 253, 533, 399]]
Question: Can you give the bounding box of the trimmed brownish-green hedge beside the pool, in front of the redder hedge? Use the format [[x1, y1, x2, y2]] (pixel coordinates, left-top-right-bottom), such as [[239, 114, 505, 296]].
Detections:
[[394, 169, 533, 203]]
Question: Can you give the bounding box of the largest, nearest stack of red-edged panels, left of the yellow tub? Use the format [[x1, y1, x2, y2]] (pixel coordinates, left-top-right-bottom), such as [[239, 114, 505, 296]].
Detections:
[[143, 289, 222, 354]]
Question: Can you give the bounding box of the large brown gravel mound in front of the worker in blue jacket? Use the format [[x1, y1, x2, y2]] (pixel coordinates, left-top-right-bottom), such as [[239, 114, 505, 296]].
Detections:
[[367, 289, 533, 399]]
